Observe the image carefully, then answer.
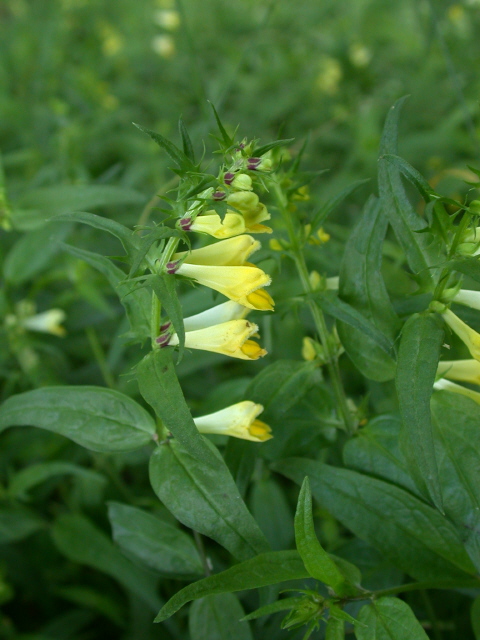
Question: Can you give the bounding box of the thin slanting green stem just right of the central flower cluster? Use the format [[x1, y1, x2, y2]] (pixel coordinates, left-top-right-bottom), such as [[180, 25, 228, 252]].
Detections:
[[272, 183, 355, 434]]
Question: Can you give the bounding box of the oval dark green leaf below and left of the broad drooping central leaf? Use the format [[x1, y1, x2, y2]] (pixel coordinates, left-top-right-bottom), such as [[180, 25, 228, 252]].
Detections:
[[108, 502, 203, 580]]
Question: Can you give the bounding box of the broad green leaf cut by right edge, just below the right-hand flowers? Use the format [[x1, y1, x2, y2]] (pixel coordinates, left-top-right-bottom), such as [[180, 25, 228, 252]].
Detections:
[[431, 391, 480, 571]]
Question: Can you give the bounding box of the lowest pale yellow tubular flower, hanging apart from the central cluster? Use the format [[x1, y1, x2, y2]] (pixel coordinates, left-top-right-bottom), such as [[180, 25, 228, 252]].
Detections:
[[193, 400, 273, 442]]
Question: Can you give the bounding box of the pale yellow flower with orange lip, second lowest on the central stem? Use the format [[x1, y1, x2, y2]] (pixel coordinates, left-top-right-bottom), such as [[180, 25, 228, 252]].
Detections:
[[168, 320, 267, 360]]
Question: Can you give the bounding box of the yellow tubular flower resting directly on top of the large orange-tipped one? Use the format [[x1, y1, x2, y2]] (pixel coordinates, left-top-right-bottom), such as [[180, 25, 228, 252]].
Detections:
[[174, 235, 260, 268]]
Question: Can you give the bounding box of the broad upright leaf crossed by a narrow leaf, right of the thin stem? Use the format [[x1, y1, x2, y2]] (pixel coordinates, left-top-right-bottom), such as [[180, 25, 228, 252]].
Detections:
[[337, 197, 399, 382]]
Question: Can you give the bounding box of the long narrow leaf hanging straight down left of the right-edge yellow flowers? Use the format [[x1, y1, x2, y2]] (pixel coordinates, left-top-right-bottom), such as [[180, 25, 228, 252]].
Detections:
[[395, 313, 444, 512]]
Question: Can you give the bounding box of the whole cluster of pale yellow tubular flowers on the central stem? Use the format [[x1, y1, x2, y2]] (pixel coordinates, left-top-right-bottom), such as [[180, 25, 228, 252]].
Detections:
[[156, 158, 274, 442]]
